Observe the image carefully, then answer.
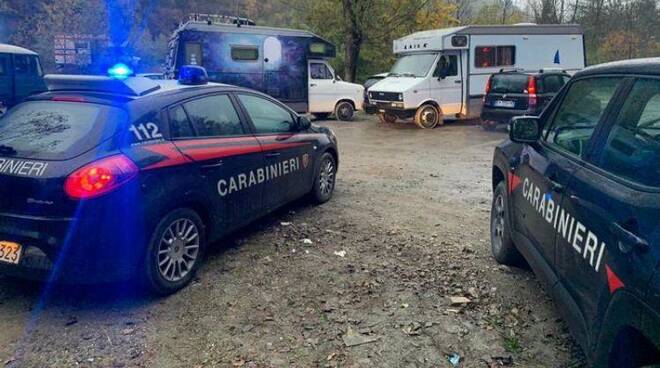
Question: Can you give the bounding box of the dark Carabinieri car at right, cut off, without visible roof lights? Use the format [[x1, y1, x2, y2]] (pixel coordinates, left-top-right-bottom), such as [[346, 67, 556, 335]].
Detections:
[[491, 58, 660, 367]]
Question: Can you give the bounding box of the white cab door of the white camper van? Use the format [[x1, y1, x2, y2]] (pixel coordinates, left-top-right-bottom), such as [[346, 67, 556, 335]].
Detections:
[[429, 51, 463, 116]]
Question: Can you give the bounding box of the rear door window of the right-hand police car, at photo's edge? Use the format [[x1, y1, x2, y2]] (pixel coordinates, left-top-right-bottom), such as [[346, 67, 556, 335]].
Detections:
[[597, 79, 660, 187]]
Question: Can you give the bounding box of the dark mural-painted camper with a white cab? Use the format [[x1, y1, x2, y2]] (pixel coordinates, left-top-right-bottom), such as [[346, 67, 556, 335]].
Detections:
[[163, 20, 364, 120]]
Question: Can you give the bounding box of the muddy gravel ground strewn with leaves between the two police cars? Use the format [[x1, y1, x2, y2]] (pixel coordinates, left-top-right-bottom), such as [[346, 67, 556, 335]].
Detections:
[[0, 116, 583, 367]]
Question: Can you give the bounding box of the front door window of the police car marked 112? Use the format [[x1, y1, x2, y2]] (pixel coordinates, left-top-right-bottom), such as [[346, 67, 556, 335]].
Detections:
[[238, 94, 294, 133]]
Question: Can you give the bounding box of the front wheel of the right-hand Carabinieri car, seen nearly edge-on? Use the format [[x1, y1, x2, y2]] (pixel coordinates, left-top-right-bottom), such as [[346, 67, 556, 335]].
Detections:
[[490, 181, 523, 266]]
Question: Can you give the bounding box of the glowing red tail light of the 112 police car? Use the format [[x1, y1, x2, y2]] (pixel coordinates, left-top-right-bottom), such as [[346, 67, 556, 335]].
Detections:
[[64, 155, 139, 199]]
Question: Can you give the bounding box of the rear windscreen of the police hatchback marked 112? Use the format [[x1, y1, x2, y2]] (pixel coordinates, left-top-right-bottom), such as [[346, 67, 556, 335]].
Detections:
[[0, 101, 127, 160]]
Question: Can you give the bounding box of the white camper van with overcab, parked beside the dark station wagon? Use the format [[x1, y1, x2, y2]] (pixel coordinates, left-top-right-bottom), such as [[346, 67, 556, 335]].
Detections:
[[368, 24, 585, 128]]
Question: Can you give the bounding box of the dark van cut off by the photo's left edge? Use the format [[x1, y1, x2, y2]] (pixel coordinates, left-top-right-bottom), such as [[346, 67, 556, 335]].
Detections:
[[0, 44, 46, 115]]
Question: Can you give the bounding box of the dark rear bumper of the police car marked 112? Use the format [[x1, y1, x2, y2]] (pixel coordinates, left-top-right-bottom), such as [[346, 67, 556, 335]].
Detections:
[[0, 208, 146, 283]]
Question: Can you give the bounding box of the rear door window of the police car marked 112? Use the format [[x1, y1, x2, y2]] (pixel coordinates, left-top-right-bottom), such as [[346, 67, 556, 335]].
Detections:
[[183, 95, 245, 137]]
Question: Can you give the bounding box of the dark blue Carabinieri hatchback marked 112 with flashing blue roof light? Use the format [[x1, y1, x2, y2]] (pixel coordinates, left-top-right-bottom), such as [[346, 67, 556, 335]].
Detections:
[[0, 66, 338, 294]]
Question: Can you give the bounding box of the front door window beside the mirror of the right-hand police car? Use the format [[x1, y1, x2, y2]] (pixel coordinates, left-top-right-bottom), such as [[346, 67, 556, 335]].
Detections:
[[546, 78, 621, 157]]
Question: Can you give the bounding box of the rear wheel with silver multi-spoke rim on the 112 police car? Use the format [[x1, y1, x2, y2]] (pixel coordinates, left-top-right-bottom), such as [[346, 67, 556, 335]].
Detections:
[[142, 208, 206, 295]]
